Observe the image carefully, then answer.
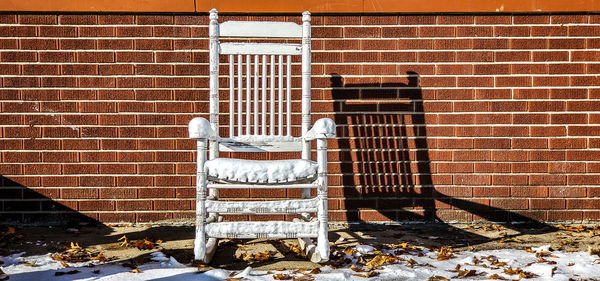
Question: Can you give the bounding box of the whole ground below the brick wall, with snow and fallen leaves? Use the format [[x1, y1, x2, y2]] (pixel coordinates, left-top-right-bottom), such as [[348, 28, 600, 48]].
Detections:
[[0, 224, 600, 280]]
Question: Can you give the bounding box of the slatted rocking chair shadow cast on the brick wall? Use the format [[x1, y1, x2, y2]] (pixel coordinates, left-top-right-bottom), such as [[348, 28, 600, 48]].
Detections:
[[330, 72, 550, 232]]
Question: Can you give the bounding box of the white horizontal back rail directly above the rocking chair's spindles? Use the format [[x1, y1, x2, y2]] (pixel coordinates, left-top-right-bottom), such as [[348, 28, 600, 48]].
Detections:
[[221, 42, 302, 55]]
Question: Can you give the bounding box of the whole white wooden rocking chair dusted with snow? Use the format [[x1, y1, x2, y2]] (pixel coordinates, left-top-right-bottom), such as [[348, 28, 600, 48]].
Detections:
[[189, 9, 335, 263]]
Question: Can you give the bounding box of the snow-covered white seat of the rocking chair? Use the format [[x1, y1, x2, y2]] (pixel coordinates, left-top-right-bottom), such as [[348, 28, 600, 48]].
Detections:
[[204, 158, 318, 184]]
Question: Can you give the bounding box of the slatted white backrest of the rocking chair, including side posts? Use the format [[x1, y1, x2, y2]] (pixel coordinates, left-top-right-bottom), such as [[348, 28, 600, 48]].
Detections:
[[209, 9, 311, 151]]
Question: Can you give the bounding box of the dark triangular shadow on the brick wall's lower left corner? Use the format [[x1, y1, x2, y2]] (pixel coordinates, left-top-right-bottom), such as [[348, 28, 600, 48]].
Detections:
[[0, 175, 102, 228]]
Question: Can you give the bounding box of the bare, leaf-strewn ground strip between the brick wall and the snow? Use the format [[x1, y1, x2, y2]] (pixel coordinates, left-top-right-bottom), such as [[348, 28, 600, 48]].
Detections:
[[0, 221, 600, 270]]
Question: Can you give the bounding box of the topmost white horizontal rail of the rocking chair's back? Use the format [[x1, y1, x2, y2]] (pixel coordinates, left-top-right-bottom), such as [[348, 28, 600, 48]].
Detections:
[[220, 21, 302, 38]]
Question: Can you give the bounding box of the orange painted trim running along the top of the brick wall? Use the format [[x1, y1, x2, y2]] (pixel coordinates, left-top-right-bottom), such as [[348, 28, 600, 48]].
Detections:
[[0, 0, 600, 14]]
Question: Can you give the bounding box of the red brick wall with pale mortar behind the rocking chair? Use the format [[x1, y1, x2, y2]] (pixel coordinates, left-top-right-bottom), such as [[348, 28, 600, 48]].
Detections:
[[0, 14, 600, 222]]
